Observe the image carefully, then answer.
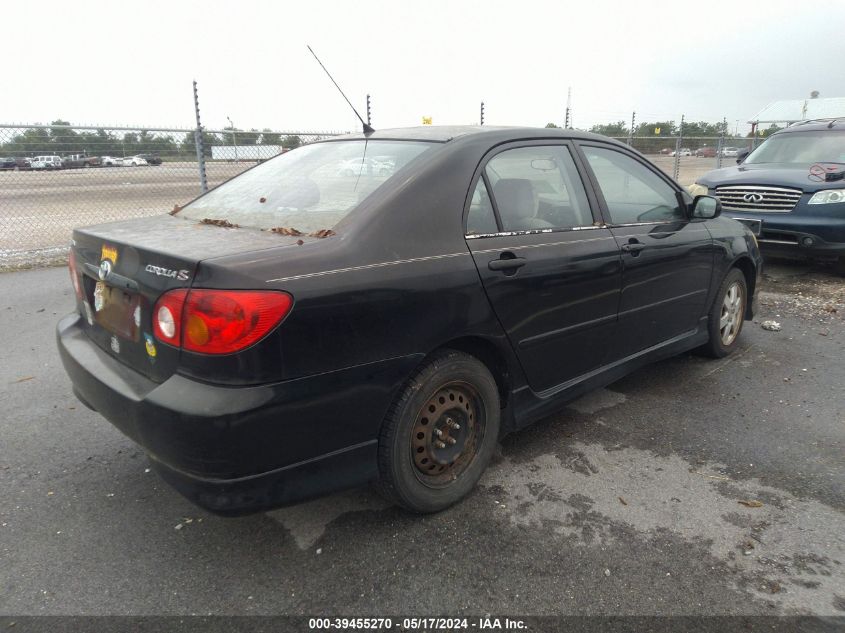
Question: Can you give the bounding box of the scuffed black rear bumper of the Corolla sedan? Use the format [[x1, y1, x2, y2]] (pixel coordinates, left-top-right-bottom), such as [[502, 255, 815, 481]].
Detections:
[[57, 314, 420, 514]]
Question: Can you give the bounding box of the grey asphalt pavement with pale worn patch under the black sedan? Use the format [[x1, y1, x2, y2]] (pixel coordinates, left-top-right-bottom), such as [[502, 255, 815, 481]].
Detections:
[[0, 266, 845, 616]]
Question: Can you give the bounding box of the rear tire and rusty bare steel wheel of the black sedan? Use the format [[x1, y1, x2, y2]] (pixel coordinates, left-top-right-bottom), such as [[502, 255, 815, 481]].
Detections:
[[376, 350, 500, 513]]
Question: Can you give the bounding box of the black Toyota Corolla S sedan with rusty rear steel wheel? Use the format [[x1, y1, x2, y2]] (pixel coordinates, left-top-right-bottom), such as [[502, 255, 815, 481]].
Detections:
[[57, 127, 761, 515]]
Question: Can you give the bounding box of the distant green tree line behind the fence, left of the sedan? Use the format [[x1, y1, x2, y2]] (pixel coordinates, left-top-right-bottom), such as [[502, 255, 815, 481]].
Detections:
[[0, 119, 303, 158]]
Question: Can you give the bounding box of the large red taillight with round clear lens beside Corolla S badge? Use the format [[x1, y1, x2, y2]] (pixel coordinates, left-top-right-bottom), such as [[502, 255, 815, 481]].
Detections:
[[153, 288, 293, 354]]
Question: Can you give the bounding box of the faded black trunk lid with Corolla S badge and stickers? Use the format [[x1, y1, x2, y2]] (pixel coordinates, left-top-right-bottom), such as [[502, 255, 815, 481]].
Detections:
[[72, 215, 295, 382]]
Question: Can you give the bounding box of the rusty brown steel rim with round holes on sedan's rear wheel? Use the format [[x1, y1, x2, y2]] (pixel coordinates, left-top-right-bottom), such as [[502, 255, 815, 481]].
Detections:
[[410, 382, 486, 488]]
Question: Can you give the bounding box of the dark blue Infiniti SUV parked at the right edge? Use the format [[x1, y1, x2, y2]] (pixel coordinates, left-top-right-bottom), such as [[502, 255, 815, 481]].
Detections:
[[691, 120, 845, 274]]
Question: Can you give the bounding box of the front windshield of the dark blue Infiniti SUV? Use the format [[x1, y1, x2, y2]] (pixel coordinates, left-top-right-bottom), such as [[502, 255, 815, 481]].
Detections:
[[745, 130, 845, 165]]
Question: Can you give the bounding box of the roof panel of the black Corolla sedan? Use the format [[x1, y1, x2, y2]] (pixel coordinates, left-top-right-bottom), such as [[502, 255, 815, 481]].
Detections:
[[334, 125, 616, 143]]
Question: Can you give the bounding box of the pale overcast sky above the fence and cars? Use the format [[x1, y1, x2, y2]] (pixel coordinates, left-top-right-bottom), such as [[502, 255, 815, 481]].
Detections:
[[6, 0, 845, 131]]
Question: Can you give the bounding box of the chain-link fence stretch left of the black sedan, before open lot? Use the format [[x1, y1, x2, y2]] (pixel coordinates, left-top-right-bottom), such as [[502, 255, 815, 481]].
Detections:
[[0, 125, 338, 269]]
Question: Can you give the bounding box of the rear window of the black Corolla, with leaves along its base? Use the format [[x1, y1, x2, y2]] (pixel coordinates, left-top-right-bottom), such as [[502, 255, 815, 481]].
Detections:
[[179, 140, 434, 234]]
